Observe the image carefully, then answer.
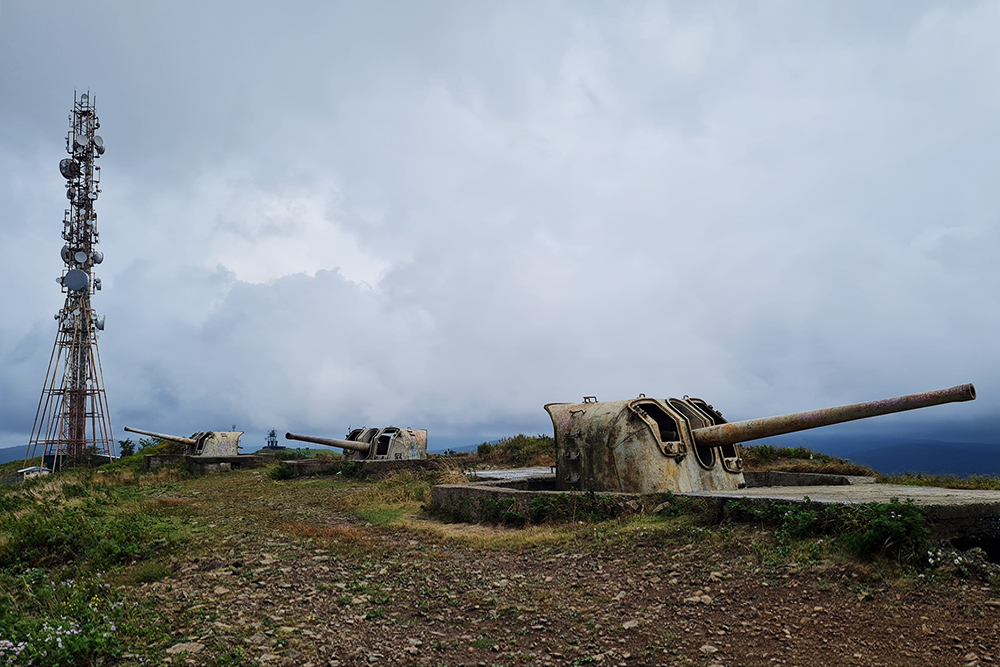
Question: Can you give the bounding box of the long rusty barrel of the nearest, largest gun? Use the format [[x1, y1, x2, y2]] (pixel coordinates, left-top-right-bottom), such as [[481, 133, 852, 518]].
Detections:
[[691, 384, 976, 447]]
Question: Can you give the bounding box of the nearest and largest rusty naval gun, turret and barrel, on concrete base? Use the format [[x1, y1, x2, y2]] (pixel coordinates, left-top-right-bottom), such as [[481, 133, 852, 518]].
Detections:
[[545, 384, 976, 493]]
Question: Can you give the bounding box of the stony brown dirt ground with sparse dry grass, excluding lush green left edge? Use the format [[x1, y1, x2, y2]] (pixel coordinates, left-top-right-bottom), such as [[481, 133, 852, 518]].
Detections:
[[126, 474, 1000, 667]]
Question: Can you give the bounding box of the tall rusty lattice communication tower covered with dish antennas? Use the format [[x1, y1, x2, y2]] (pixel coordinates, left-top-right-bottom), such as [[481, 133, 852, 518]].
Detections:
[[25, 93, 115, 472]]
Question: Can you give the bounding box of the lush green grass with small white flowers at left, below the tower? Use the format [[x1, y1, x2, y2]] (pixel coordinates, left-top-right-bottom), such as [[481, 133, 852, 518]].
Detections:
[[0, 457, 188, 667]]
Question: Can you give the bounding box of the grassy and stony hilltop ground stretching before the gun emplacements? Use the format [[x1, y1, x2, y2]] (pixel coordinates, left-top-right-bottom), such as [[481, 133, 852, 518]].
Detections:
[[0, 448, 1000, 667]]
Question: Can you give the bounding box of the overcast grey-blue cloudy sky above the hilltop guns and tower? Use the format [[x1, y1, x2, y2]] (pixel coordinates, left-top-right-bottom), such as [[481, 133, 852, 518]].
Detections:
[[0, 0, 1000, 450]]
